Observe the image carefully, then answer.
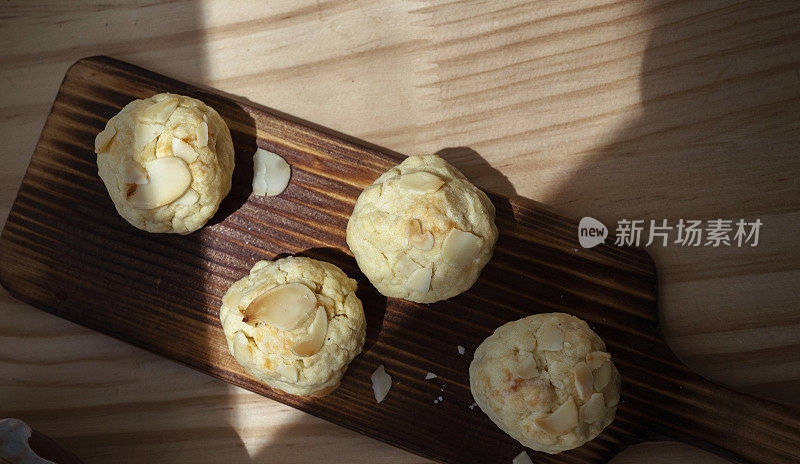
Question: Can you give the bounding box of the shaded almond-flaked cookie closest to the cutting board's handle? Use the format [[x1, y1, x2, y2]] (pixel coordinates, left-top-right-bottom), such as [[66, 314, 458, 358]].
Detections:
[[469, 313, 620, 454]]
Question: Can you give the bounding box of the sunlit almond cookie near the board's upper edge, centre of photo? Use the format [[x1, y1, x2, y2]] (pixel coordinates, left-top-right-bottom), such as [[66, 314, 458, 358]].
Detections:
[[347, 155, 497, 303]]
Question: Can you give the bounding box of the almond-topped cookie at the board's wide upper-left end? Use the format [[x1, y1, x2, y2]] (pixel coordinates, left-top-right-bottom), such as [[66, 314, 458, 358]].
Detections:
[[95, 93, 234, 234]]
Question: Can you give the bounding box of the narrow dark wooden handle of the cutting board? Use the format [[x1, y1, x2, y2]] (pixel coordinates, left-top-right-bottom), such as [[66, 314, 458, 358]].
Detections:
[[650, 370, 800, 464]]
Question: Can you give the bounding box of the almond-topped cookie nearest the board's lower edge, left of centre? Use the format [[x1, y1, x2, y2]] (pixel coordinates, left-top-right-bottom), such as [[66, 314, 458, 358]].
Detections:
[[219, 257, 366, 396]]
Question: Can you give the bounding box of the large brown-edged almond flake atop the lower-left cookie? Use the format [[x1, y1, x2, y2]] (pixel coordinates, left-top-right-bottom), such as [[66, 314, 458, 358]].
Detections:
[[242, 283, 317, 330]]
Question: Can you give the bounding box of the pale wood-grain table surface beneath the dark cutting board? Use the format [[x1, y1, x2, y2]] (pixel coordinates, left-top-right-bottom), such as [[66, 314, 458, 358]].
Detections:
[[0, 0, 800, 464]]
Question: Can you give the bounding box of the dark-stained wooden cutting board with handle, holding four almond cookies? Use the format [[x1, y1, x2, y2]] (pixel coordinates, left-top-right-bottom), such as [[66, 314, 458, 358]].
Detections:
[[0, 57, 800, 463]]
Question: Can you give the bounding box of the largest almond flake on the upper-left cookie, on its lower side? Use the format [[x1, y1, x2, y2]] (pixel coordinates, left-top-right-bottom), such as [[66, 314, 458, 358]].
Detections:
[[128, 156, 192, 209]]
